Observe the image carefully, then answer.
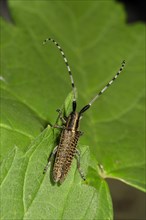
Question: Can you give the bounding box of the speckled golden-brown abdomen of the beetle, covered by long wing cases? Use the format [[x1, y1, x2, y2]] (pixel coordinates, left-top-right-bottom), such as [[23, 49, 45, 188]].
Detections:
[[53, 130, 80, 183]]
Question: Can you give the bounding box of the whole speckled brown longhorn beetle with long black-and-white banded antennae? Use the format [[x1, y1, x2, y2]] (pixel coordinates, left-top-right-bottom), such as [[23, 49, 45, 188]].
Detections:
[[43, 38, 125, 183]]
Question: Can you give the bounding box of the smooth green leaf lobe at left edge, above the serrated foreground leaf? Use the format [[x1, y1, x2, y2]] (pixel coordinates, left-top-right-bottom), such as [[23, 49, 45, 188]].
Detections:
[[0, 88, 44, 158]]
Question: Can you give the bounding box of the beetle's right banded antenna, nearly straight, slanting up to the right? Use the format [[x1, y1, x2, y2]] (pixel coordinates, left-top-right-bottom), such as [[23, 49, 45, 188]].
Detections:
[[79, 60, 125, 115]]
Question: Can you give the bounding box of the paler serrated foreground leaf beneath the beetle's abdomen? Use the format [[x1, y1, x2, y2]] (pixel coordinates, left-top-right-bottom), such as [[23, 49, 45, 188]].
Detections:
[[1, 127, 111, 219]]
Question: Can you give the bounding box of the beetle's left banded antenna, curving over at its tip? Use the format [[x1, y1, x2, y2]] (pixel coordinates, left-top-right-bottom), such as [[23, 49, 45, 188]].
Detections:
[[43, 38, 76, 112]]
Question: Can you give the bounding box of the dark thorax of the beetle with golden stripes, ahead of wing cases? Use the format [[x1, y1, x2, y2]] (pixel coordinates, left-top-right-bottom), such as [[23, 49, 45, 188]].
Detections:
[[66, 112, 79, 131]]
